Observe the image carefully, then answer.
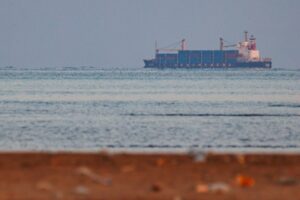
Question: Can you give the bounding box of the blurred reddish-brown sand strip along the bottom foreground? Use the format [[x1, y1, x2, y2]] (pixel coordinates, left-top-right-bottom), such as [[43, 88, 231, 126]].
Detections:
[[0, 153, 300, 200]]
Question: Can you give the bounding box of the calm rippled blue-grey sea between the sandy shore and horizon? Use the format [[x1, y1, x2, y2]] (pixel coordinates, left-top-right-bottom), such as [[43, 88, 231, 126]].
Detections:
[[0, 67, 300, 152]]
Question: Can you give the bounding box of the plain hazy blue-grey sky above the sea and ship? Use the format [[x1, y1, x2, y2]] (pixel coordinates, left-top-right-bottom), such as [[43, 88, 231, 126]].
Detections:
[[0, 0, 300, 68]]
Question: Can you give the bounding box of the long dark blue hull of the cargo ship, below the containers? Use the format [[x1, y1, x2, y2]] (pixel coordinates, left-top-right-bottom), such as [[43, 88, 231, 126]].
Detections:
[[144, 60, 272, 69]]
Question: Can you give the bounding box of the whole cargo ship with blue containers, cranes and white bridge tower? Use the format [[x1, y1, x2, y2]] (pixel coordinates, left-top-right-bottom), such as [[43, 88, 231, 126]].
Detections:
[[144, 31, 272, 69]]
